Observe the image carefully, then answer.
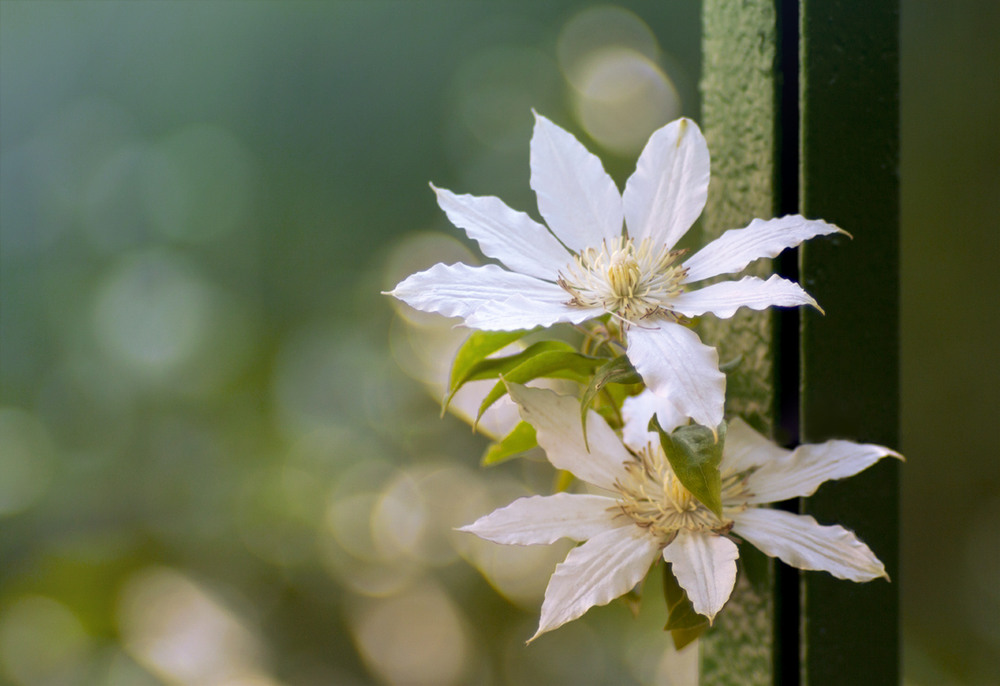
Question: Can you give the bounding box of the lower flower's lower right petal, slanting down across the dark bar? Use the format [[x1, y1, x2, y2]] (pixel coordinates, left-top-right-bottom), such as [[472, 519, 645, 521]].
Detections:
[[733, 507, 889, 581]]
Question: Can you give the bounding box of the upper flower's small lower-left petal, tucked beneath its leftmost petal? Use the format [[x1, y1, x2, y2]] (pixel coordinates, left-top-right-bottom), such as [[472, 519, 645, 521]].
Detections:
[[465, 292, 604, 331]]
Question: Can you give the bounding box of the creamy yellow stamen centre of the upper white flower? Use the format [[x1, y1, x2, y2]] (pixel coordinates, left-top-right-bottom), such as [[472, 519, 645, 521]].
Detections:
[[559, 238, 687, 322]]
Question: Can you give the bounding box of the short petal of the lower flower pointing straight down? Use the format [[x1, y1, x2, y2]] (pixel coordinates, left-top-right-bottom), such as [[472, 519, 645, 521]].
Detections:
[[663, 529, 740, 622]]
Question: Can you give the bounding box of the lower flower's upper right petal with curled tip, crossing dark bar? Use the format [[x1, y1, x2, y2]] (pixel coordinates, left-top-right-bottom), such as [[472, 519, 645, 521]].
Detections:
[[744, 436, 903, 503]]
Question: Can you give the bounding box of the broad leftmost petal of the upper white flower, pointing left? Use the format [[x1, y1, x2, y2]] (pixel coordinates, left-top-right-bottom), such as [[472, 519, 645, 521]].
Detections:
[[389, 263, 589, 331]]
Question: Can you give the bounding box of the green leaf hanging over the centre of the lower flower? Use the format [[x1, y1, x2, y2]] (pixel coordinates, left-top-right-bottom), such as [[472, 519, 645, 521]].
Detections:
[[649, 414, 726, 519]]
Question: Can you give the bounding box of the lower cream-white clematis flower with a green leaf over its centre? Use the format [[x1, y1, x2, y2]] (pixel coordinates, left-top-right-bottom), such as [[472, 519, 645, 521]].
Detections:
[[461, 384, 901, 640]]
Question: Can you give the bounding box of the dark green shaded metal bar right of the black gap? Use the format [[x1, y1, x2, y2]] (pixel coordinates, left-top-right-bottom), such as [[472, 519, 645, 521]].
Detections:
[[800, 0, 900, 686]]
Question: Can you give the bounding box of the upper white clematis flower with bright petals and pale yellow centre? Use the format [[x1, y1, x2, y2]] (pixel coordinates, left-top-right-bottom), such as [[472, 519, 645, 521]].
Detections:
[[391, 114, 840, 427]]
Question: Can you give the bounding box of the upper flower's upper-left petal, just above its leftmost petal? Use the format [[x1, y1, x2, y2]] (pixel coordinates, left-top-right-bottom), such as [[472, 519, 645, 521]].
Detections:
[[431, 185, 572, 281]]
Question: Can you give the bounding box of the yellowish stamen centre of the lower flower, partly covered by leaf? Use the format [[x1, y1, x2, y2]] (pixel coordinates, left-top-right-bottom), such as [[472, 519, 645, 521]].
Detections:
[[615, 445, 748, 545]]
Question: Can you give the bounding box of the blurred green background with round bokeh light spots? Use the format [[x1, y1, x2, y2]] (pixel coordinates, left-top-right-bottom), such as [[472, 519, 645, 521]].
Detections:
[[0, 0, 1000, 686]]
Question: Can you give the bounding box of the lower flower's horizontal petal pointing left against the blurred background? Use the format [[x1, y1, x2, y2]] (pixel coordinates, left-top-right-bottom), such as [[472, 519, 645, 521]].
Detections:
[[459, 493, 621, 545]]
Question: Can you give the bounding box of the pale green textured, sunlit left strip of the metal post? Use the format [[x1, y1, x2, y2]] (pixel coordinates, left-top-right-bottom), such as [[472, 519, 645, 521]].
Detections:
[[701, 0, 778, 686]]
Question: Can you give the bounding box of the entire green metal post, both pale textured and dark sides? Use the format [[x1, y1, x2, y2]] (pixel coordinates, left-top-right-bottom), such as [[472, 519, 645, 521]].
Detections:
[[701, 0, 899, 686]]
